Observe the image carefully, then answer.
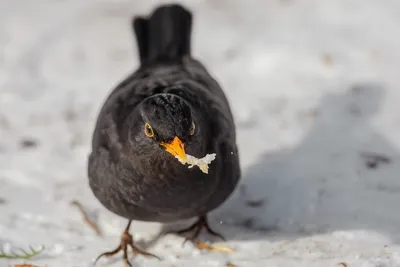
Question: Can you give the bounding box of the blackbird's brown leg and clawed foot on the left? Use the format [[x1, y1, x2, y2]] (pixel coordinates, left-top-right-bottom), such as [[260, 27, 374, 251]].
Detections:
[[94, 221, 160, 267]]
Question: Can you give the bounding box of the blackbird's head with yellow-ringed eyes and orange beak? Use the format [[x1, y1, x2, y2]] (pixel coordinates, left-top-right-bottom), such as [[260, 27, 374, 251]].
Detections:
[[129, 94, 201, 161]]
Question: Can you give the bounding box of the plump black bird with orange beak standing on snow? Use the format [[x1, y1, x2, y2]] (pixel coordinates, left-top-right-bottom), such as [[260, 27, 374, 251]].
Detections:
[[88, 4, 241, 266]]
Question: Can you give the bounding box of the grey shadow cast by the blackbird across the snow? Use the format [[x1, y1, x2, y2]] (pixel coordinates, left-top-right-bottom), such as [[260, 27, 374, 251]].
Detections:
[[214, 83, 400, 246]]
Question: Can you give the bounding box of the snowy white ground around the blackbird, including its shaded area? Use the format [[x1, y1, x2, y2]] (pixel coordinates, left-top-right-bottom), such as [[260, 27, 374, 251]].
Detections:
[[0, 0, 400, 267]]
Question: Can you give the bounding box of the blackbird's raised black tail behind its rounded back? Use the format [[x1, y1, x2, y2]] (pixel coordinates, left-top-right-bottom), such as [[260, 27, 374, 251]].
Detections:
[[132, 4, 192, 65]]
